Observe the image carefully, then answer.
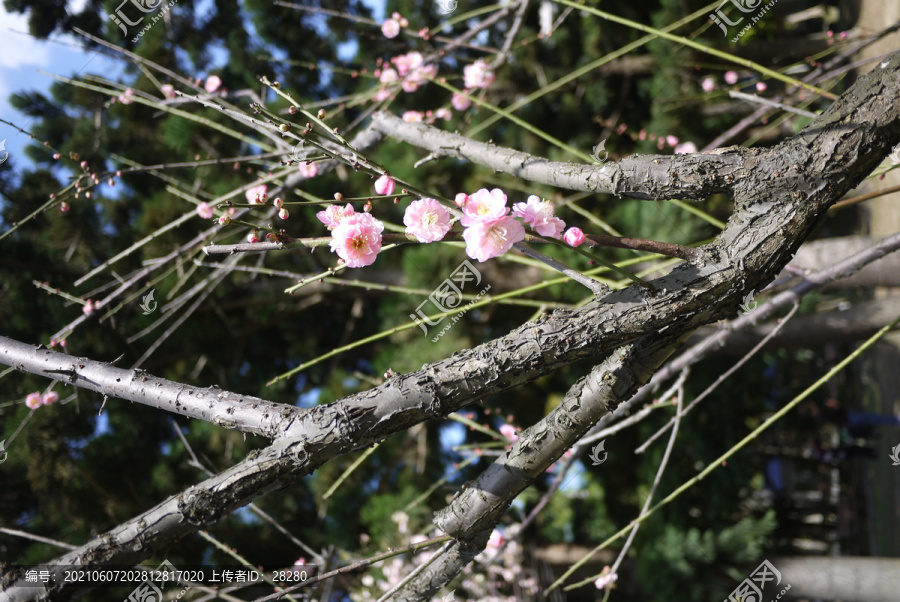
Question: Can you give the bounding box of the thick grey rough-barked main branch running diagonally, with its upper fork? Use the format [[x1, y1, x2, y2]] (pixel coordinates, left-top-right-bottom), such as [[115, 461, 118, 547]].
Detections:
[[7, 49, 900, 600]]
